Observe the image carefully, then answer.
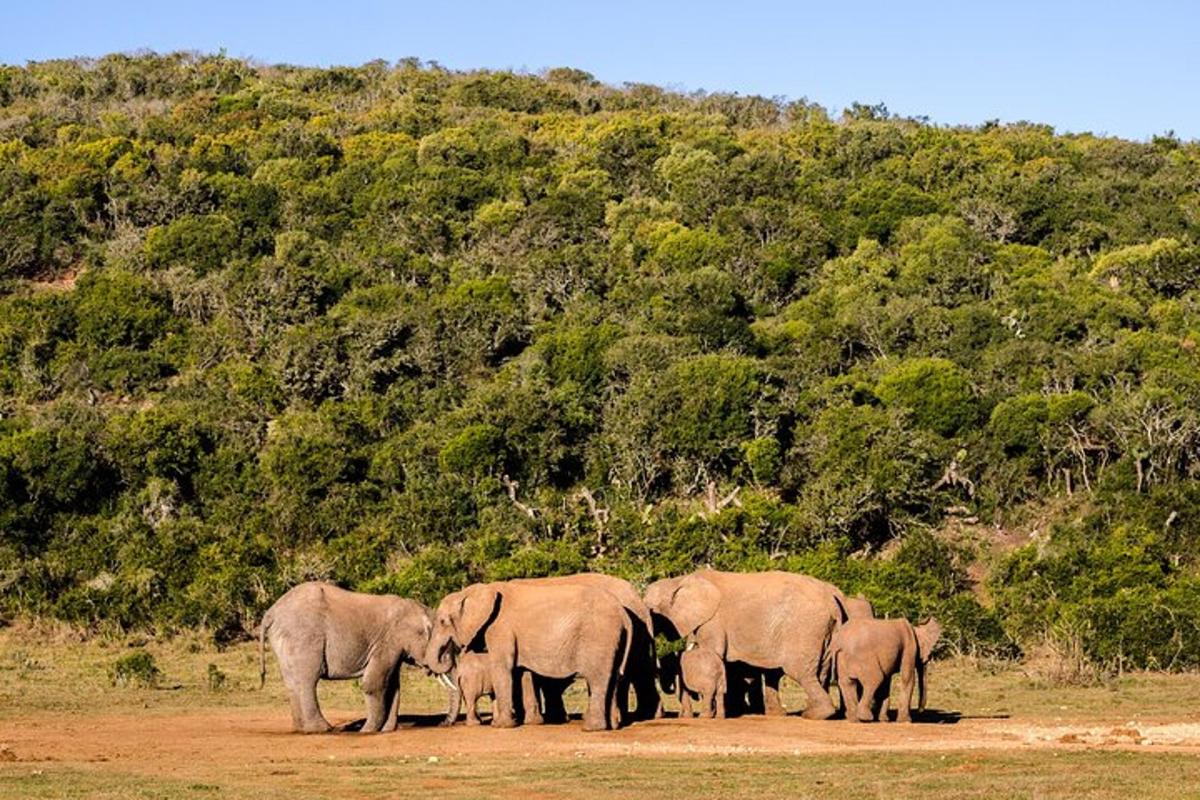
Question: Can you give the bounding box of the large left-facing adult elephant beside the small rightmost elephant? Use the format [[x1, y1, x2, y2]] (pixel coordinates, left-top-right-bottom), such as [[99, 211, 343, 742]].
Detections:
[[646, 570, 846, 720]]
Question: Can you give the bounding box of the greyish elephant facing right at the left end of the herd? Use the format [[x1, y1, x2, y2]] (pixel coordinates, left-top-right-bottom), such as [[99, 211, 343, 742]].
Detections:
[[258, 582, 432, 733]]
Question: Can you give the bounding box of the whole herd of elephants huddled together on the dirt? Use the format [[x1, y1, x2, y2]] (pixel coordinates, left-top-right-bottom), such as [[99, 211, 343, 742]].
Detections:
[[258, 570, 940, 733]]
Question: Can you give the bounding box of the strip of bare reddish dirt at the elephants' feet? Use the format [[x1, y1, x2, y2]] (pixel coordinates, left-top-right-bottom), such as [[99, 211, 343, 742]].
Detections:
[[7, 709, 1200, 777]]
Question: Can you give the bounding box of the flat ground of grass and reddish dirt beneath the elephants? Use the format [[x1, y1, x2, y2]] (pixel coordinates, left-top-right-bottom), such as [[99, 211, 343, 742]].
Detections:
[[0, 626, 1200, 800]]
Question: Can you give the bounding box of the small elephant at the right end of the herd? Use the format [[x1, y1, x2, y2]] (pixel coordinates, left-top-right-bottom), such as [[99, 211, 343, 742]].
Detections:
[[829, 619, 942, 722]]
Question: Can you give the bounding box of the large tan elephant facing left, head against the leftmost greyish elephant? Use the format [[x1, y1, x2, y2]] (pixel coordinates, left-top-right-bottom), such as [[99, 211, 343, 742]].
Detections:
[[426, 581, 632, 730]]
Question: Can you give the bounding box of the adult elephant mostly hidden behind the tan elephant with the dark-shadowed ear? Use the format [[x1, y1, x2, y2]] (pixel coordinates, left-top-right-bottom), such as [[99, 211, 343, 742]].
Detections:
[[509, 572, 662, 722]]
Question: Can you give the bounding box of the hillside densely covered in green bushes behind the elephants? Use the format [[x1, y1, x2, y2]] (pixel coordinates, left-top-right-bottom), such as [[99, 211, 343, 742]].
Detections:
[[0, 54, 1200, 668]]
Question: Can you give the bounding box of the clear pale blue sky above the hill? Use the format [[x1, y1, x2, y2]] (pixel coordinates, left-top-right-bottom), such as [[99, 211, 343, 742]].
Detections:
[[0, 0, 1200, 139]]
